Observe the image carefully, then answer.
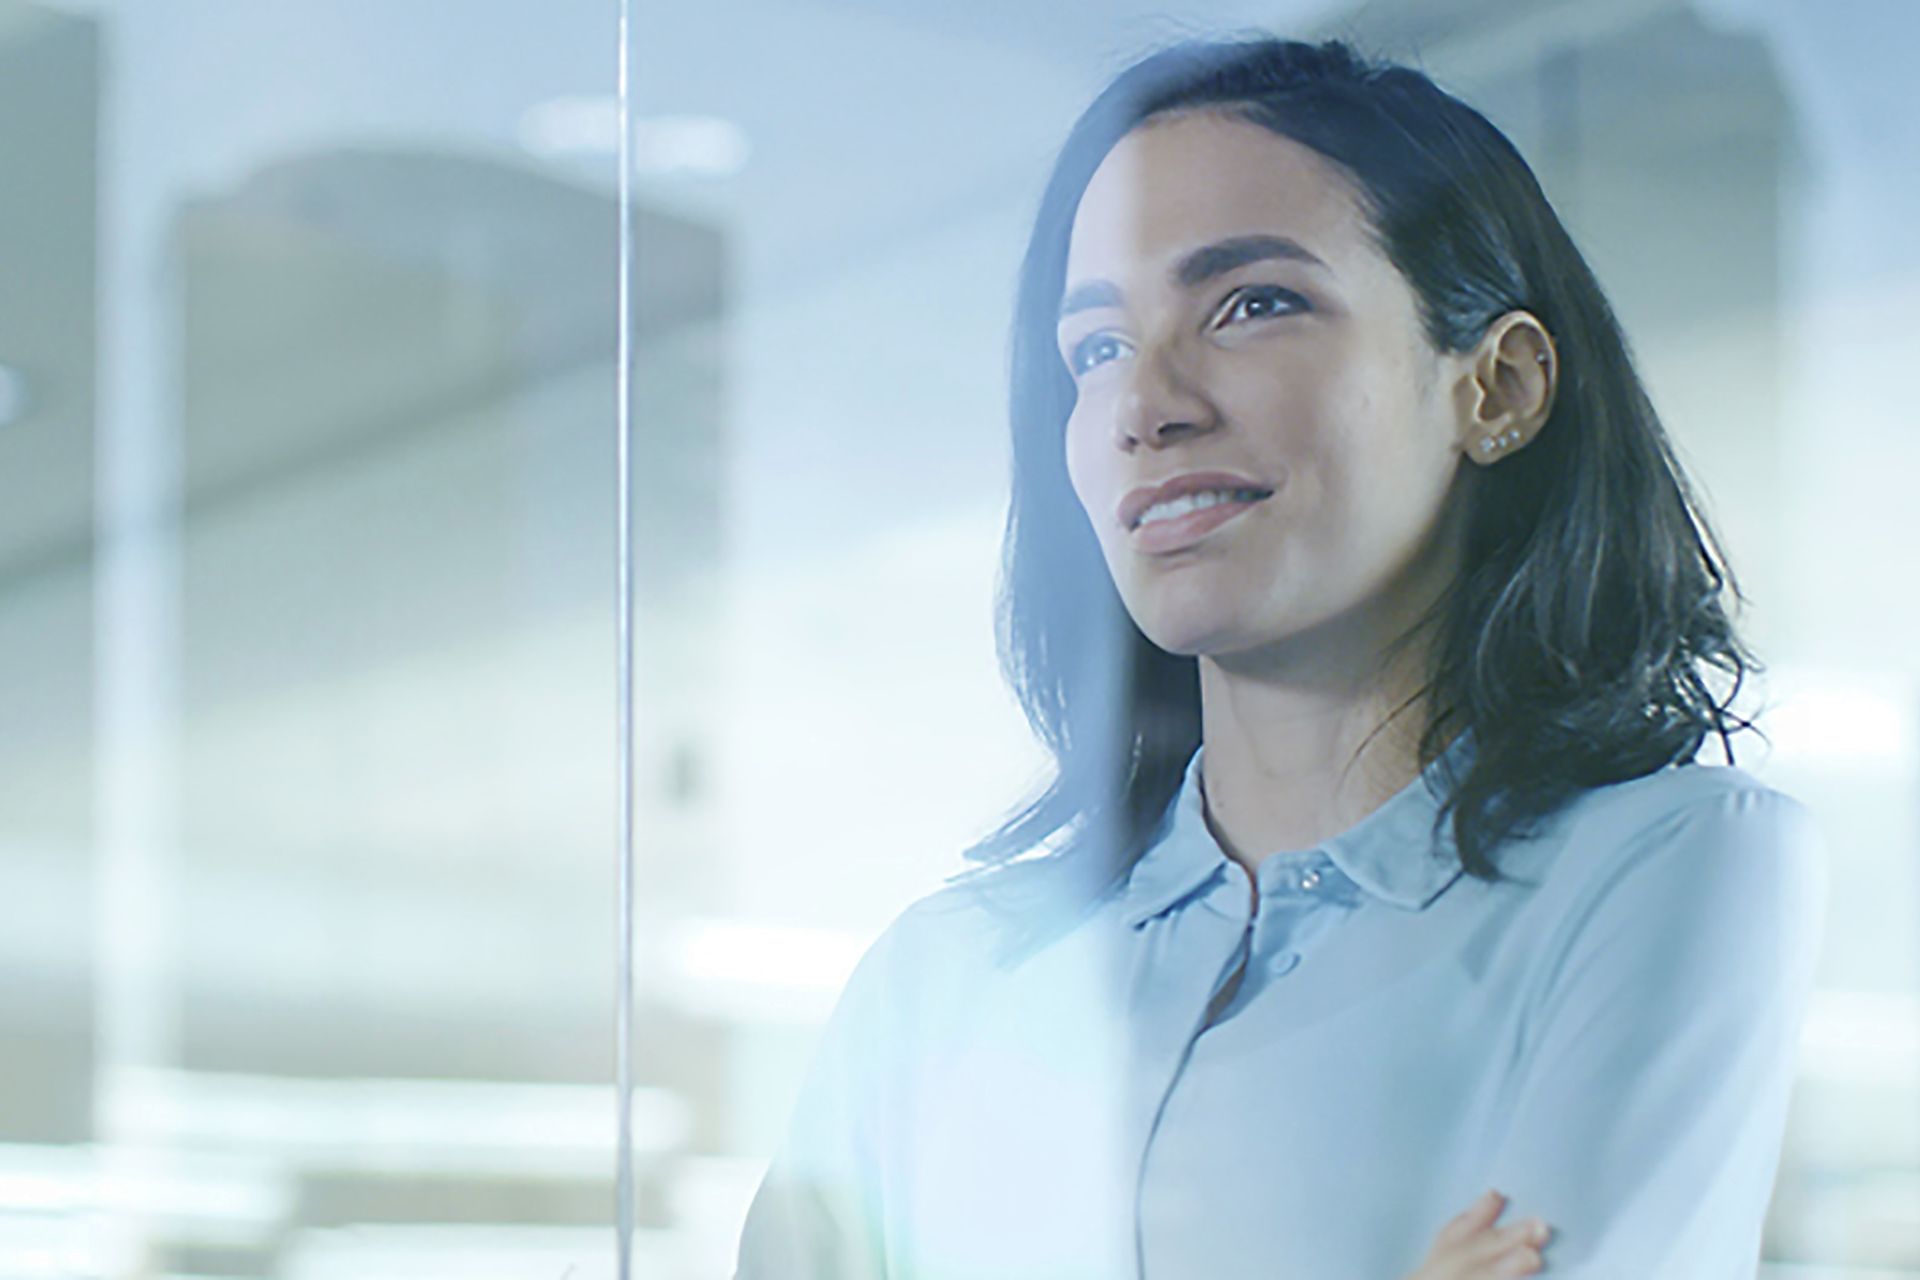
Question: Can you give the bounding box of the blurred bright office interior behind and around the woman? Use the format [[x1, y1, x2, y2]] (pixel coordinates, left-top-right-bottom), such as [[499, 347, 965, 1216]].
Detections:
[[0, 0, 1920, 1280]]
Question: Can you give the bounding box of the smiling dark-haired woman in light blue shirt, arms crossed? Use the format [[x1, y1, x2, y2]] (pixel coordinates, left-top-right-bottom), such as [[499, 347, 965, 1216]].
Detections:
[[739, 32, 1826, 1280]]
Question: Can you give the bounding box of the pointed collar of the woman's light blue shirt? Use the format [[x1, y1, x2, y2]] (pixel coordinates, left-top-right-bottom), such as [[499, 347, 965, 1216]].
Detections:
[[1121, 729, 1473, 925]]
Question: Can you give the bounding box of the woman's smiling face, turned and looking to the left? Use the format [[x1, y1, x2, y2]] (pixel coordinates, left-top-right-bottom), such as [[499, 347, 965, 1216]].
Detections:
[[1060, 113, 1473, 656]]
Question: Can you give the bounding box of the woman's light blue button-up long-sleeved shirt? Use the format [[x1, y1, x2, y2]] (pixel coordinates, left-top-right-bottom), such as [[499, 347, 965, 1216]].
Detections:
[[737, 737, 1828, 1280]]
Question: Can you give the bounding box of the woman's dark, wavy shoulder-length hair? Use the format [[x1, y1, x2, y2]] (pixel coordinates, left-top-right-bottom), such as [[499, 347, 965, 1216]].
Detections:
[[956, 36, 1764, 950]]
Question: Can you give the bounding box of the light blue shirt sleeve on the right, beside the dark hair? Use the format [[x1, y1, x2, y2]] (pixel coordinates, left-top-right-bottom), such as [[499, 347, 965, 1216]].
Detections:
[[1492, 789, 1828, 1280]]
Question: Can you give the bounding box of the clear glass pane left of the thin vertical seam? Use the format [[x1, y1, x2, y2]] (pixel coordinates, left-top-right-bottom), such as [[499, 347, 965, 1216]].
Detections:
[[0, 0, 637, 1280]]
